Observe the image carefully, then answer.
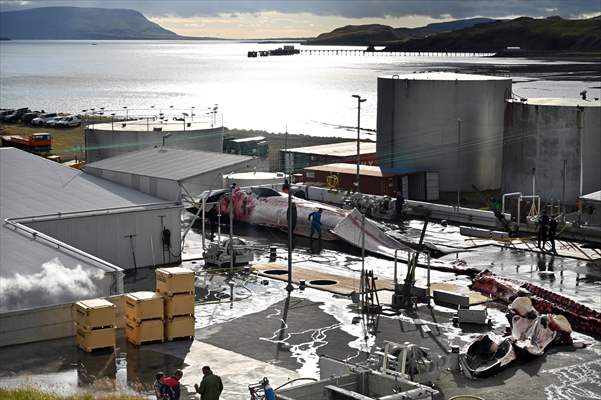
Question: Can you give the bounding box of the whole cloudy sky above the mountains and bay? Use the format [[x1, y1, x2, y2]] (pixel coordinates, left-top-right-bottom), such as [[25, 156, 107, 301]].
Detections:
[[0, 0, 601, 39]]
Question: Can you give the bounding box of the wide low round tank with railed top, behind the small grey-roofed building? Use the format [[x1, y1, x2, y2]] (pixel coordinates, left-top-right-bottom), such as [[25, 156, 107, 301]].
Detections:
[[84, 118, 223, 163]]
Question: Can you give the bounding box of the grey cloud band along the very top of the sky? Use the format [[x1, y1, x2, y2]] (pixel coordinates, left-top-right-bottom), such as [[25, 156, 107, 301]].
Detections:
[[0, 0, 599, 19]]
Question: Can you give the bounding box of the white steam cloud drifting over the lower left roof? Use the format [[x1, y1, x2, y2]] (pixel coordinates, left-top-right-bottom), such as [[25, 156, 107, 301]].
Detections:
[[0, 258, 104, 310]]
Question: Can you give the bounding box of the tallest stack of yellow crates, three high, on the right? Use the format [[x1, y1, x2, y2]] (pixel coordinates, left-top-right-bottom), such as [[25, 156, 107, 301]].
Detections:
[[156, 267, 194, 341]]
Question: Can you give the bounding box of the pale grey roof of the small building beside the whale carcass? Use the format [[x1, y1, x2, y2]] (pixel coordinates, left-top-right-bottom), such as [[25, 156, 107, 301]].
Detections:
[[84, 147, 253, 181]]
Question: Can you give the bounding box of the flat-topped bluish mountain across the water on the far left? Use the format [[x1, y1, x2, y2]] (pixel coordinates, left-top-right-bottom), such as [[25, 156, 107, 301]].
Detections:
[[0, 7, 180, 40]]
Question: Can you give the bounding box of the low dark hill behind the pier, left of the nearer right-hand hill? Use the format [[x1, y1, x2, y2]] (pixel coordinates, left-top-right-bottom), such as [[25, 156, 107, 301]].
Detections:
[[306, 18, 495, 46]]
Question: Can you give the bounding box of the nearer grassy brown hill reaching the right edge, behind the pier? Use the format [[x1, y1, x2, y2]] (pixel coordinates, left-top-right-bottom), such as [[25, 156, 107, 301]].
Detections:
[[386, 17, 601, 52]]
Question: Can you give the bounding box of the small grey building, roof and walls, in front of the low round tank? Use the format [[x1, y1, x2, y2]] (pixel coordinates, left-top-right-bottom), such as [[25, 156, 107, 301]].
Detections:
[[84, 147, 256, 201]]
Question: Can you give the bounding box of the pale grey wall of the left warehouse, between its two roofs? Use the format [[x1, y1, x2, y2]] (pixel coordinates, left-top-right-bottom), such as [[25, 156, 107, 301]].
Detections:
[[26, 205, 181, 269]]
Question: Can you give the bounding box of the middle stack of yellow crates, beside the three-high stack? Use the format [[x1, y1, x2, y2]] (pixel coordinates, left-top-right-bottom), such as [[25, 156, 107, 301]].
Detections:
[[125, 292, 164, 346]]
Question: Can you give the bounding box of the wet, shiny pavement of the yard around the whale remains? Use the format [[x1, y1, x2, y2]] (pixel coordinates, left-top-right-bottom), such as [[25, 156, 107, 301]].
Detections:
[[0, 221, 601, 400]]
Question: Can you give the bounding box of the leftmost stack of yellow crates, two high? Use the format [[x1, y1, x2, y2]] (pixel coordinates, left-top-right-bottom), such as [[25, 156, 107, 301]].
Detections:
[[74, 299, 117, 353]]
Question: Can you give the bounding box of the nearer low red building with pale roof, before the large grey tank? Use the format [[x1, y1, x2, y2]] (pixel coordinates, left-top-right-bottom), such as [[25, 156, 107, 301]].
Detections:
[[303, 163, 439, 200]]
